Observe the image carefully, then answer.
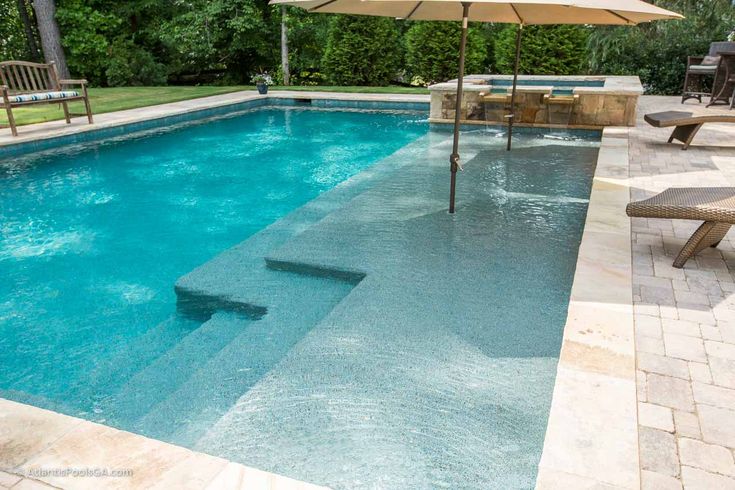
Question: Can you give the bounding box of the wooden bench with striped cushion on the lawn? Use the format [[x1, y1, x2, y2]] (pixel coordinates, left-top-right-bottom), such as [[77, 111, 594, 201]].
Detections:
[[0, 61, 94, 136]]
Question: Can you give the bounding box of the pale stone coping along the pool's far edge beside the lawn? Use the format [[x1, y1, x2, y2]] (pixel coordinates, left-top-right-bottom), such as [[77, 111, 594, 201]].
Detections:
[[0, 90, 429, 146]]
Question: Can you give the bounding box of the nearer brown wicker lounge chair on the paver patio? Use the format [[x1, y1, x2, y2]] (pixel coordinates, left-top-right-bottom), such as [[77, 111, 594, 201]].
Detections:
[[625, 187, 735, 269]]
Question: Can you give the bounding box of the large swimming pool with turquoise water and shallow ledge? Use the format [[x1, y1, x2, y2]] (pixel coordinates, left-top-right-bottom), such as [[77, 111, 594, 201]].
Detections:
[[0, 101, 597, 488]]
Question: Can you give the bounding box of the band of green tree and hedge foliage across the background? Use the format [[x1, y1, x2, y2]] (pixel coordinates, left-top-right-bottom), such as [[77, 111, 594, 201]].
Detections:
[[7, 0, 735, 94]]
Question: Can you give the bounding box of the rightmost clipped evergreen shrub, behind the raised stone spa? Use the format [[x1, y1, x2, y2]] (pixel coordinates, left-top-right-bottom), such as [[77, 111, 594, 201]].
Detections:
[[495, 25, 589, 75]]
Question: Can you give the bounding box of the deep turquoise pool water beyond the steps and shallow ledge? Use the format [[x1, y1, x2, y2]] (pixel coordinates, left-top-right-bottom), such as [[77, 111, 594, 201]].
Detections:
[[0, 109, 428, 410]]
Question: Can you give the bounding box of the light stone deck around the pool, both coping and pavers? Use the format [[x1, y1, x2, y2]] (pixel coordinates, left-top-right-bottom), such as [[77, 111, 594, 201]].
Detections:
[[0, 92, 735, 489]]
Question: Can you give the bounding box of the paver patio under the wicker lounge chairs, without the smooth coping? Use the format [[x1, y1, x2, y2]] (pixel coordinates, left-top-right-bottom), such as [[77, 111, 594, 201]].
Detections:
[[629, 97, 735, 490]]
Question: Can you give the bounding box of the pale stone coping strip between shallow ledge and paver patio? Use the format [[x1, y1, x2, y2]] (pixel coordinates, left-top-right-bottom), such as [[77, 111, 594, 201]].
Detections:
[[537, 128, 640, 489]]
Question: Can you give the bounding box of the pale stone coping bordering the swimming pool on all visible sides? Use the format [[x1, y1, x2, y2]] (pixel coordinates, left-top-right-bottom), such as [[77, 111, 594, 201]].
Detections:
[[0, 91, 640, 489]]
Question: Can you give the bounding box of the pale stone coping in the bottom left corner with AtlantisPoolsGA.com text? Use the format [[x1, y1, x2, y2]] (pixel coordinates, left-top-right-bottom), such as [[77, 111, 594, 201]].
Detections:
[[0, 398, 325, 490]]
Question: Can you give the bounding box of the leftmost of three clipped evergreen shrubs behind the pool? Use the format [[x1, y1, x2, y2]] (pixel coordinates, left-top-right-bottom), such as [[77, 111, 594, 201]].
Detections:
[[322, 15, 400, 85]]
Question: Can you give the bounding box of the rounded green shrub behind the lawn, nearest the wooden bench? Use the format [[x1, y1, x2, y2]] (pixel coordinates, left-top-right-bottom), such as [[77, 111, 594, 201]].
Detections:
[[105, 40, 167, 87]]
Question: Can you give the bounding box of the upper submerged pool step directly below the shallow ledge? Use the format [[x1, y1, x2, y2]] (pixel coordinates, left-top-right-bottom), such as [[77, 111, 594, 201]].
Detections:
[[128, 262, 353, 446]]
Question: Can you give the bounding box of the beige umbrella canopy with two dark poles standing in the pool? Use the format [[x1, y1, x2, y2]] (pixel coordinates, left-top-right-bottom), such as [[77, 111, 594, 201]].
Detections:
[[270, 0, 683, 213]]
